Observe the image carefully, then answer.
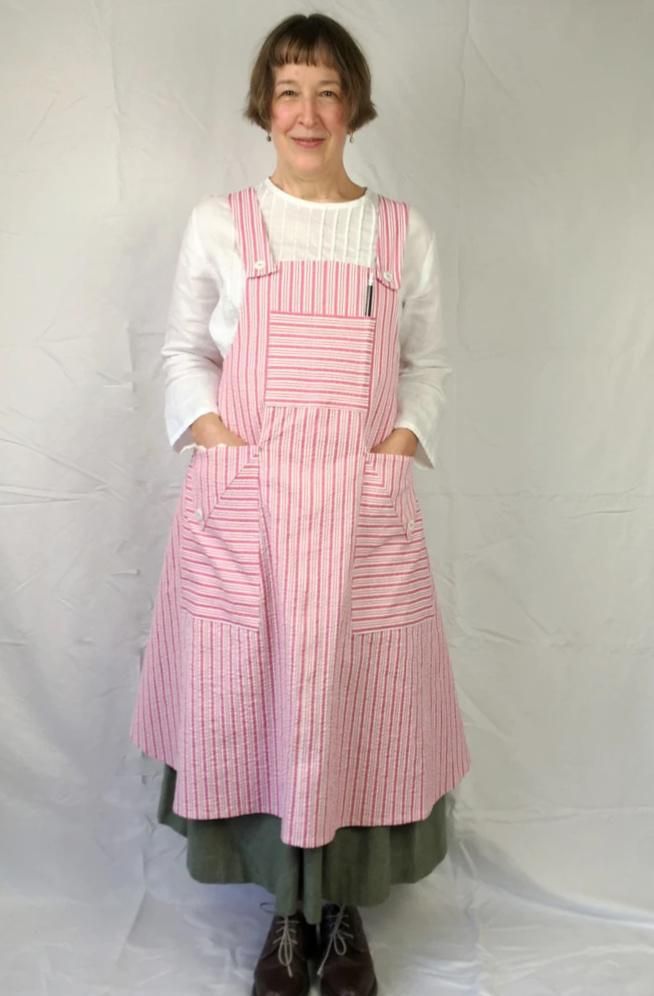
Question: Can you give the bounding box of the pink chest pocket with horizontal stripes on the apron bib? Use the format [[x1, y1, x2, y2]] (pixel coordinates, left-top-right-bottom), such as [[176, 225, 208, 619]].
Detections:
[[265, 311, 376, 412]]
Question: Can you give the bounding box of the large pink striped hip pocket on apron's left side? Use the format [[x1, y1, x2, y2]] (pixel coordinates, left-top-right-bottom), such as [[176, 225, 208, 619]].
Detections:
[[181, 443, 261, 629]]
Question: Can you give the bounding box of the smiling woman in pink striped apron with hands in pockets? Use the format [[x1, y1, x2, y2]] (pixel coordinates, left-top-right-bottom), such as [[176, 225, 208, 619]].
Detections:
[[131, 14, 470, 996]]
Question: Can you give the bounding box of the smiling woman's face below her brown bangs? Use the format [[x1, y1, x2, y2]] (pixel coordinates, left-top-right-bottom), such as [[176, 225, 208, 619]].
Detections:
[[270, 63, 348, 176]]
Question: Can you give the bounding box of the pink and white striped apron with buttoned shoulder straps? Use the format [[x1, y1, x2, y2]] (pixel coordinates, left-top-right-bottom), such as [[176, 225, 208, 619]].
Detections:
[[130, 187, 470, 847]]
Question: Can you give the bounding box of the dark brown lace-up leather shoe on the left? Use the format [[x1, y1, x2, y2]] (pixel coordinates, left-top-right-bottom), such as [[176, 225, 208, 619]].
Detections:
[[252, 904, 316, 996]]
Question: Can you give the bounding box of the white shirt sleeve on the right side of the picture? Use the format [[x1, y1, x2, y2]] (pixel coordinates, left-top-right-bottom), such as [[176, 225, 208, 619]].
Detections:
[[395, 208, 452, 468]]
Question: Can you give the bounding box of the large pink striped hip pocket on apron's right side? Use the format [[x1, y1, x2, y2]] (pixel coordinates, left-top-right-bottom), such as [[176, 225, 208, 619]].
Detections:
[[352, 452, 434, 633]]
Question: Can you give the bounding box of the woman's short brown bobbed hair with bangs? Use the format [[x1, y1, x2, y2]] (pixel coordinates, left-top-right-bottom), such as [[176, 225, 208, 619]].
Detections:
[[243, 14, 377, 131]]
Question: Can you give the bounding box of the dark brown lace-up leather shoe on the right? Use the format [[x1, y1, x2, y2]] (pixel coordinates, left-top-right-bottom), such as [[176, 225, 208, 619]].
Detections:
[[317, 903, 377, 996]]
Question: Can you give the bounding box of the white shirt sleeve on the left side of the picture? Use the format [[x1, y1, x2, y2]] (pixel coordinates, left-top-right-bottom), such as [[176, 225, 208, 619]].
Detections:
[[161, 205, 222, 453]]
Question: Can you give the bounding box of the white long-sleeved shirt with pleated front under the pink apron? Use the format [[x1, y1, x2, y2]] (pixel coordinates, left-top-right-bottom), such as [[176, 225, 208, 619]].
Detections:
[[161, 177, 451, 468]]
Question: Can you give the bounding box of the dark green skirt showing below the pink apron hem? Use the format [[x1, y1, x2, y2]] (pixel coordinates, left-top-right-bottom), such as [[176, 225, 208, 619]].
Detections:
[[157, 764, 447, 923]]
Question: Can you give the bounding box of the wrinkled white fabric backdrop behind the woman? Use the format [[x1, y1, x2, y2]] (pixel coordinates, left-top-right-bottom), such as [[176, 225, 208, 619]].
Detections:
[[0, 0, 654, 996]]
